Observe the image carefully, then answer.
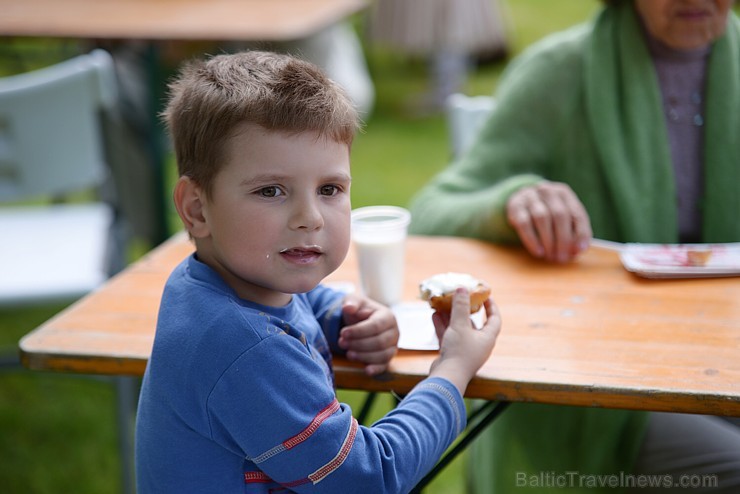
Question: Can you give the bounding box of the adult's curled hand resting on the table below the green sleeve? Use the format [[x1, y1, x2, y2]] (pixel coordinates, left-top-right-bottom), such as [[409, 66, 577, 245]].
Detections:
[[506, 182, 592, 263]]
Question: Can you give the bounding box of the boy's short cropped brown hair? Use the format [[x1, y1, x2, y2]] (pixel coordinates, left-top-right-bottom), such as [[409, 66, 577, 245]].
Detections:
[[162, 51, 360, 195]]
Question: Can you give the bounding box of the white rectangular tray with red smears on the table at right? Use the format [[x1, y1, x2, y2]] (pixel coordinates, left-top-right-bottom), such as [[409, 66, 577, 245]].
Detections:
[[619, 242, 740, 278]]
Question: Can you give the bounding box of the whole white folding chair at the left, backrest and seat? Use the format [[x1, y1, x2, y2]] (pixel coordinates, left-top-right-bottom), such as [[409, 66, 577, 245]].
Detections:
[[0, 50, 122, 307]]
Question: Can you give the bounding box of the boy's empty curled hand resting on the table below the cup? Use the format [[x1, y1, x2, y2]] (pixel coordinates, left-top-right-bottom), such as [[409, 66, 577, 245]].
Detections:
[[338, 294, 398, 376]]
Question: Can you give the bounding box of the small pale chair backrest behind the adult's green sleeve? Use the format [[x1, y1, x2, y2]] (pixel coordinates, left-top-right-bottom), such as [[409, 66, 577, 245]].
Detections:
[[446, 93, 496, 158]]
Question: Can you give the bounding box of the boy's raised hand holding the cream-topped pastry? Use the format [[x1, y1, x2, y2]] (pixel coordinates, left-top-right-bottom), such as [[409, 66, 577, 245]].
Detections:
[[430, 288, 501, 394]]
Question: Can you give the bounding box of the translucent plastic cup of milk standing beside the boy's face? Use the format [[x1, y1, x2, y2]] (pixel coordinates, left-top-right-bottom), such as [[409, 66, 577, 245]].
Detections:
[[352, 206, 411, 306]]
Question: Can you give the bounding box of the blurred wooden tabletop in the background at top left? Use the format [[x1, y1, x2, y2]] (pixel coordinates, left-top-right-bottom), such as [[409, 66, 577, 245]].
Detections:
[[0, 0, 367, 41]]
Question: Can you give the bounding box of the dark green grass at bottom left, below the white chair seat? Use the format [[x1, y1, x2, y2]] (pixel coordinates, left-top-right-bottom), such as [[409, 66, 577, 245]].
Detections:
[[0, 306, 120, 494]]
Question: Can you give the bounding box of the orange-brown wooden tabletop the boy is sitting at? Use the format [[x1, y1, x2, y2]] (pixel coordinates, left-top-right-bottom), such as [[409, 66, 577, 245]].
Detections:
[[21, 235, 740, 416]]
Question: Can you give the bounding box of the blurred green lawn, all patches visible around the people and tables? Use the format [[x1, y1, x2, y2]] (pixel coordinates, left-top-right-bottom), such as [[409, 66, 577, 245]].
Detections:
[[0, 0, 599, 494]]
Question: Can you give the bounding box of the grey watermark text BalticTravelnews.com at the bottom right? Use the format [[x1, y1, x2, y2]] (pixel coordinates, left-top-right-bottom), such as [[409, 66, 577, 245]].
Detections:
[[516, 471, 719, 489]]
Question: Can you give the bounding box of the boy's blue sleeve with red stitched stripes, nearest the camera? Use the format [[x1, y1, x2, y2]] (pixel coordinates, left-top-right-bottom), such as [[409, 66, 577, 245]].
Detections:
[[208, 335, 466, 494]]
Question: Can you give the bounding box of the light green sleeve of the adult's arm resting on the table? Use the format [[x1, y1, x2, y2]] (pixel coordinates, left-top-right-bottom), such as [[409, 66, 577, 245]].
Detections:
[[410, 27, 583, 242]]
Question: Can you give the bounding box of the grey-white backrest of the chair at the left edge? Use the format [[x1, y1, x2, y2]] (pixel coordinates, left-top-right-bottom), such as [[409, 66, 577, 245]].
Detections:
[[0, 50, 117, 202]]
